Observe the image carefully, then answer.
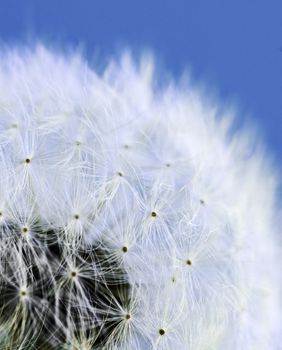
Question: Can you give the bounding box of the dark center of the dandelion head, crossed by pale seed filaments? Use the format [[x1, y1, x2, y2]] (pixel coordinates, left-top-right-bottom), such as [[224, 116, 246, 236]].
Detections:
[[0, 222, 131, 350]]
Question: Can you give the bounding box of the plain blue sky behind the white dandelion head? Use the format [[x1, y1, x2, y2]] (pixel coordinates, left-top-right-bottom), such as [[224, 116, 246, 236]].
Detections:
[[0, 0, 282, 165]]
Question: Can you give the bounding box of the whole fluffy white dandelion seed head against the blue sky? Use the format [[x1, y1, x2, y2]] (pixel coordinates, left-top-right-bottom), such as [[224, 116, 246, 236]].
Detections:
[[0, 46, 282, 350]]
